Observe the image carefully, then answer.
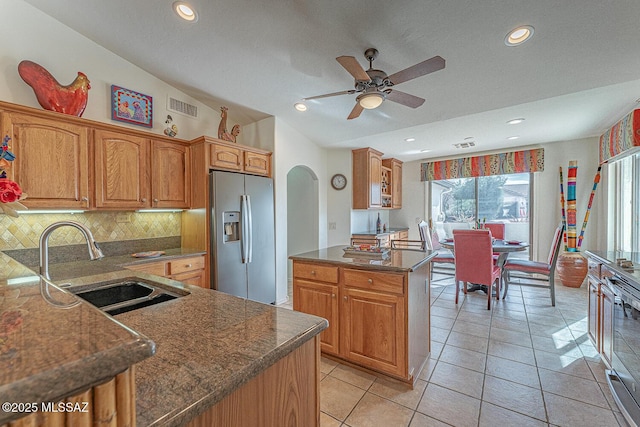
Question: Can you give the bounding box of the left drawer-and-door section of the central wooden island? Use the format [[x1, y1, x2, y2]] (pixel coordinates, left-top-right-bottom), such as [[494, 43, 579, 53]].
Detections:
[[293, 263, 340, 355]]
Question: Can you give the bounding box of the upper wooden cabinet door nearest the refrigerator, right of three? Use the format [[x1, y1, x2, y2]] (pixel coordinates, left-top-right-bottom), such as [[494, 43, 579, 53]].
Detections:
[[151, 141, 191, 209]]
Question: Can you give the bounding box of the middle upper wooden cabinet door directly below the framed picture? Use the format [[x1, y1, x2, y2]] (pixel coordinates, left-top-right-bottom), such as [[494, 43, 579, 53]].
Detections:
[[95, 130, 151, 209]]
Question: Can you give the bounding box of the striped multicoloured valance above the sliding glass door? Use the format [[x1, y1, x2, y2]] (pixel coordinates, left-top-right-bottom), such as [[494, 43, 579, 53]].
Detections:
[[420, 148, 544, 181]]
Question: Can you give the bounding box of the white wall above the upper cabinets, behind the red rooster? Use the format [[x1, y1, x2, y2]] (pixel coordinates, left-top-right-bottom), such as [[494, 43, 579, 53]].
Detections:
[[0, 0, 243, 143]]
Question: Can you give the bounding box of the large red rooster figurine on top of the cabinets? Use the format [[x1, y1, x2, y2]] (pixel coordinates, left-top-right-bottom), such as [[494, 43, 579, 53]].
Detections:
[[18, 61, 91, 117]]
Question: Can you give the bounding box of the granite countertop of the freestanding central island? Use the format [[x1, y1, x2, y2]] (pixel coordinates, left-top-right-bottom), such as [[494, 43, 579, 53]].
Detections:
[[289, 245, 437, 272]]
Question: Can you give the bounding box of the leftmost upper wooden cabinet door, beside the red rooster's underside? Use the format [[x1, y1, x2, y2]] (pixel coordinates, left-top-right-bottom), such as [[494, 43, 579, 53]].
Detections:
[[2, 113, 90, 209]]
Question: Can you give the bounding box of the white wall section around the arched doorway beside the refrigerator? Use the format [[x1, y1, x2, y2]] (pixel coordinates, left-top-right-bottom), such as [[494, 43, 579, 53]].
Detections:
[[274, 118, 329, 302]]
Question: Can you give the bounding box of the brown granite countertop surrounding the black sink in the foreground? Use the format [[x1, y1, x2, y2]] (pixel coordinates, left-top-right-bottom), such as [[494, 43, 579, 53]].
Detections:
[[0, 250, 328, 426]]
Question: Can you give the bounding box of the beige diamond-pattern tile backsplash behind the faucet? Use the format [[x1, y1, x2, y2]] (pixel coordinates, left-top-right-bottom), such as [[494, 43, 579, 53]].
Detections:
[[0, 212, 181, 251]]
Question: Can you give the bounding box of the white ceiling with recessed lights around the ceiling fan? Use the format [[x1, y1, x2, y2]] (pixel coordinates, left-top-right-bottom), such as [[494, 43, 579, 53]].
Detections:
[[26, 0, 640, 161]]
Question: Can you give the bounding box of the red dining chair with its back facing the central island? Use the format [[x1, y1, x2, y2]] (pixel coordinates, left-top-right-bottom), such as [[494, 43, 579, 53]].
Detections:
[[453, 230, 502, 310]]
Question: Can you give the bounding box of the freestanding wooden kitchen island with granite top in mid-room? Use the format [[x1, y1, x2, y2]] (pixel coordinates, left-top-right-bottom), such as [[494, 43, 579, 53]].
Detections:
[[290, 246, 435, 384]]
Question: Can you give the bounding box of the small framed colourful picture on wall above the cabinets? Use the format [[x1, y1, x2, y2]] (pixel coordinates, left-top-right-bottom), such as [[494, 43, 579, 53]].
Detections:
[[111, 85, 153, 128]]
